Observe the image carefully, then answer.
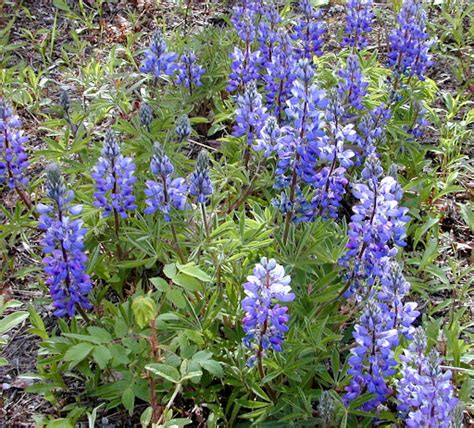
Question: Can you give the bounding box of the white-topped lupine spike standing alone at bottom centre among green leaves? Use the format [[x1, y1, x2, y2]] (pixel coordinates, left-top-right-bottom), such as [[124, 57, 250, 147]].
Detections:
[[242, 257, 295, 367]]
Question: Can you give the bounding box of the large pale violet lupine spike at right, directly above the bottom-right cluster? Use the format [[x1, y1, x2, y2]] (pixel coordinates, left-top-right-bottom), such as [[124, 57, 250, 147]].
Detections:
[[339, 154, 410, 297]]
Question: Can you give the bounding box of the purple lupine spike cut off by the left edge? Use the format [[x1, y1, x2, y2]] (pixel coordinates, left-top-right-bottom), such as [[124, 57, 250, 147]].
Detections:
[[0, 98, 29, 189]]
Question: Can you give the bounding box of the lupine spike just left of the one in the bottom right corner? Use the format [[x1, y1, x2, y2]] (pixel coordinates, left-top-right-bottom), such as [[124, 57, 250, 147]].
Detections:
[[344, 299, 398, 411]]
